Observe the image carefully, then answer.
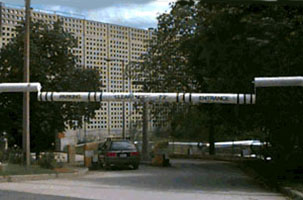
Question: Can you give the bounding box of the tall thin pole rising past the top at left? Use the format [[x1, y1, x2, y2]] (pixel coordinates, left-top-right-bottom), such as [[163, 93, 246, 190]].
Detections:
[[22, 0, 30, 166]]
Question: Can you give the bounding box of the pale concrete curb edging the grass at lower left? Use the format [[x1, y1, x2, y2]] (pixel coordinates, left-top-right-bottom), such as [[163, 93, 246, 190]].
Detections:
[[0, 168, 88, 183]]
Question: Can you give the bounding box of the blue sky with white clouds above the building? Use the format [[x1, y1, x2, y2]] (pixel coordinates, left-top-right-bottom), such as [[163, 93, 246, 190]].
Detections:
[[0, 0, 175, 29]]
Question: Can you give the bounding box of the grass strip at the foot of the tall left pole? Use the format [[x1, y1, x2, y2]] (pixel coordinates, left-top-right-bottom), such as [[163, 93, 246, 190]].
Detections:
[[0, 164, 56, 176]]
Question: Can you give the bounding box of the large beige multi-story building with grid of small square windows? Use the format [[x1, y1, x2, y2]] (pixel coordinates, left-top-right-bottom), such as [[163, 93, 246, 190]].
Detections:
[[0, 3, 154, 147]]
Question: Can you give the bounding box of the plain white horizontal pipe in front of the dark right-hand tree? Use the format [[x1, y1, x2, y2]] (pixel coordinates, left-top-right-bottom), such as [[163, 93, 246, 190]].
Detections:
[[254, 76, 303, 87]]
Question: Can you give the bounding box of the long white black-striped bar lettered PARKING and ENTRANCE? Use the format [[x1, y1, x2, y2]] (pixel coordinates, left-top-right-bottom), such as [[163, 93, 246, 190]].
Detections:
[[38, 92, 256, 104]]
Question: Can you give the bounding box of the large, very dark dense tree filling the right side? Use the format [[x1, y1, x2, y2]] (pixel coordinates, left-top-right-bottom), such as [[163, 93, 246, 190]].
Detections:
[[185, 1, 303, 158]]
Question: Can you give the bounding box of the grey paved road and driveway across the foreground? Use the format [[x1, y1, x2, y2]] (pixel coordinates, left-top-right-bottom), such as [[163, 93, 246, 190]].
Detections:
[[0, 160, 286, 200]]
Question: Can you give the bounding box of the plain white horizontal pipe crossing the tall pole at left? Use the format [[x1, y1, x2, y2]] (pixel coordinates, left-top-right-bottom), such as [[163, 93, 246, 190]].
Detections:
[[0, 83, 42, 92]]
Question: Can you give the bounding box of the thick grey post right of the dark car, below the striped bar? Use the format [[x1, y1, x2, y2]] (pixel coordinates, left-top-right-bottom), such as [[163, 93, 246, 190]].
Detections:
[[142, 102, 149, 160]]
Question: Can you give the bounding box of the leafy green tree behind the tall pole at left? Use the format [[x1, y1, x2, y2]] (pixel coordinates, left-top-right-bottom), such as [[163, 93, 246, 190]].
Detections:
[[0, 21, 101, 152]]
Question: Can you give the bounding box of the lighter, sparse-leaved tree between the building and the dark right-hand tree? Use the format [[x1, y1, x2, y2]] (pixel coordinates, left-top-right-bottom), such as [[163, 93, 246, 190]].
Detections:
[[130, 1, 199, 144]]
